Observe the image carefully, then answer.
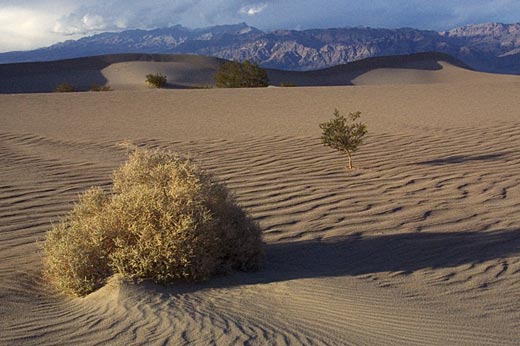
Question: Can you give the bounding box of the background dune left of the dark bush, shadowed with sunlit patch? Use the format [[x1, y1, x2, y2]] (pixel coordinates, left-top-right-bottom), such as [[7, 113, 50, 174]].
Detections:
[[0, 53, 221, 93]]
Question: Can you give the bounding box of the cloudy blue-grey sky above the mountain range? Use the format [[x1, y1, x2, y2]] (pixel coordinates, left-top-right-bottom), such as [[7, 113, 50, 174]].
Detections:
[[0, 0, 520, 52]]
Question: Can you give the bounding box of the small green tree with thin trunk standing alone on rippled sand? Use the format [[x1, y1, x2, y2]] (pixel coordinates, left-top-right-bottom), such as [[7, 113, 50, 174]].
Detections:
[[320, 109, 367, 169]]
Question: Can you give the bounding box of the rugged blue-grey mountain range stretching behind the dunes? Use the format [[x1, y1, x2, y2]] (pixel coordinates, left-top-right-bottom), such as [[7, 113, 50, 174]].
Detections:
[[0, 23, 520, 74]]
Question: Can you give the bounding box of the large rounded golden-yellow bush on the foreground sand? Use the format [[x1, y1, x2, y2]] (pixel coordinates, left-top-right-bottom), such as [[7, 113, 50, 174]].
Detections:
[[43, 150, 262, 296]]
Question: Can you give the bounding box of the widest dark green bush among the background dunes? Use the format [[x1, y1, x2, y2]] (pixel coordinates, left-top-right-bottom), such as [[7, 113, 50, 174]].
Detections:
[[215, 60, 269, 88]]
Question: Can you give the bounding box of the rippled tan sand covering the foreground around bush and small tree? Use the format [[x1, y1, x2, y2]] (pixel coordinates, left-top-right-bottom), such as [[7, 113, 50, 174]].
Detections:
[[0, 56, 520, 345]]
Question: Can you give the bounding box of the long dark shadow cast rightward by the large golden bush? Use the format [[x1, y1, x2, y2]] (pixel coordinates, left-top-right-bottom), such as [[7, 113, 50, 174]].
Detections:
[[145, 229, 520, 295]]
